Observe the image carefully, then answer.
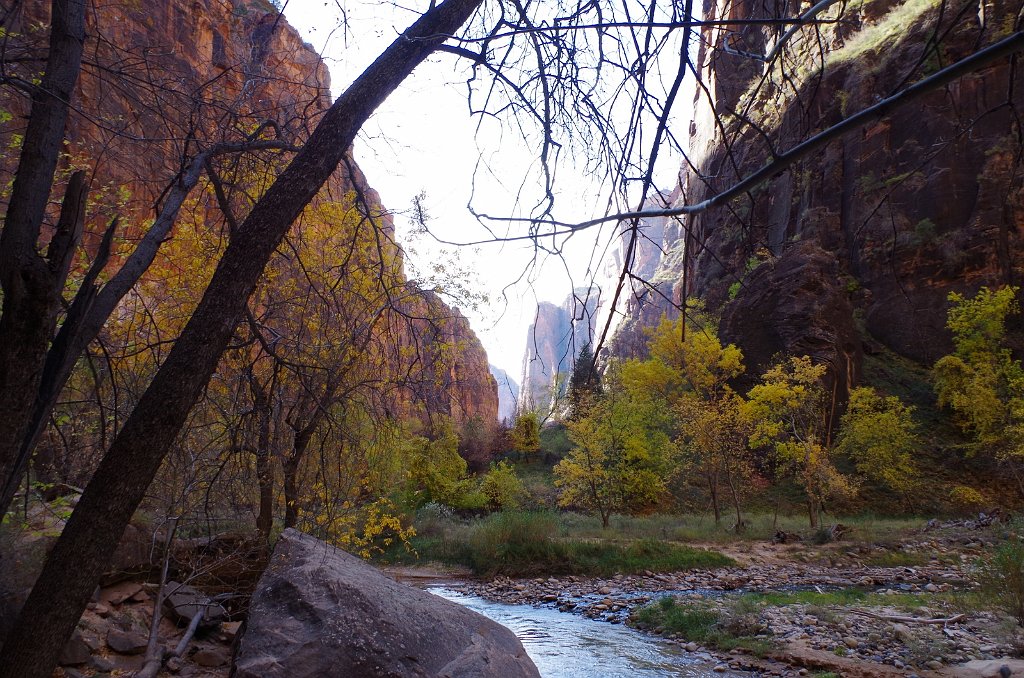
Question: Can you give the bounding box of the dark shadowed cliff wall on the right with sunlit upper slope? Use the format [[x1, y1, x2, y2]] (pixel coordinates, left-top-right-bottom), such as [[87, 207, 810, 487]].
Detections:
[[614, 0, 1024, 397]]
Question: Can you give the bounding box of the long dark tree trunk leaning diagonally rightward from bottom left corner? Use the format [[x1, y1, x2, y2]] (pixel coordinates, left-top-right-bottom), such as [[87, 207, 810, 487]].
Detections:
[[0, 0, 481, 678]]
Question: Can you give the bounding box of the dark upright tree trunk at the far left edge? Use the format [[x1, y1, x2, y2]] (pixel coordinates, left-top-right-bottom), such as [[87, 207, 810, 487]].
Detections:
[[0, 0, 85, 515]]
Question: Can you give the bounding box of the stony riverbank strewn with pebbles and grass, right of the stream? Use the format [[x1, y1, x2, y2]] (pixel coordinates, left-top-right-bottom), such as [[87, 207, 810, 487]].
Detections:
[[409, 521, 1024, 676]]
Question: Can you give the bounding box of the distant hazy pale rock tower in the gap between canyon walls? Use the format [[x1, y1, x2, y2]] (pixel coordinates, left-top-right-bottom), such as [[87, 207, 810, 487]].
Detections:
[[519, 288, 601, 415]]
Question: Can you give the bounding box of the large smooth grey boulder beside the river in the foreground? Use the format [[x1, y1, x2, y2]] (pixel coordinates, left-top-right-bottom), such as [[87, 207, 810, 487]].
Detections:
[[236, 529, 540, 678]]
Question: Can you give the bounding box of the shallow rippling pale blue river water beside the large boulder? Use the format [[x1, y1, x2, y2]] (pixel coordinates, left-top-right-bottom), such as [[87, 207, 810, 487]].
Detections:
[[428, 587, 751, 678]]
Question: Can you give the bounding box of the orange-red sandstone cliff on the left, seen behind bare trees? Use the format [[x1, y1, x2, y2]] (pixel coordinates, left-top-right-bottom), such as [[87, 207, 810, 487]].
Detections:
[[0, 0, 498, 424]]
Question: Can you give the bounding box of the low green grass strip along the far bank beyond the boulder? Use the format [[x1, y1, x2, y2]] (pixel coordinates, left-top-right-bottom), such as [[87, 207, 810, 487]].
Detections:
[[385, 511, 733, 576]]
